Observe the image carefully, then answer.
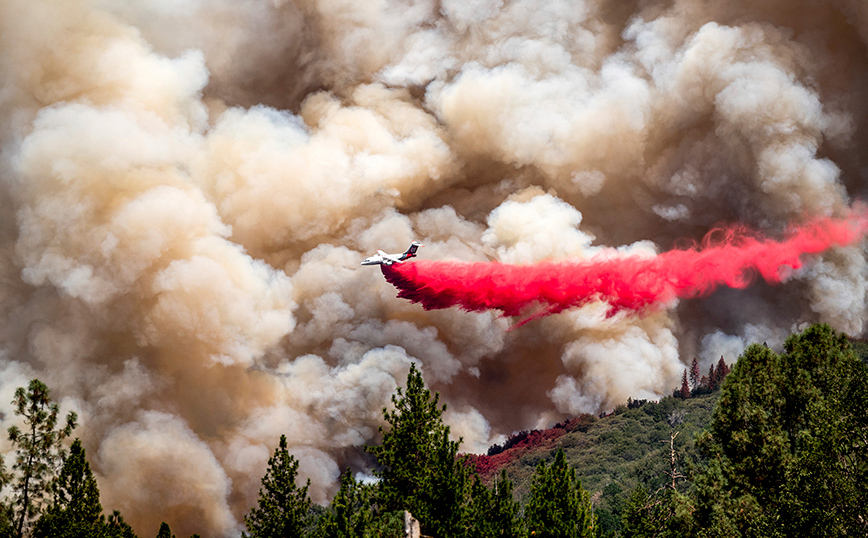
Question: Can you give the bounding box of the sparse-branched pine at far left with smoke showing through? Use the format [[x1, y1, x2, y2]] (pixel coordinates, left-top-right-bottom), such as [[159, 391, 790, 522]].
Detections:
[[8, 379, 78, 537]]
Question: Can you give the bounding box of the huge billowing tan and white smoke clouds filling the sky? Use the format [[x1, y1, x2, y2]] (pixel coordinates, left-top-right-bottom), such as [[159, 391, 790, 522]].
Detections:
[[0, 0, 868, 536]]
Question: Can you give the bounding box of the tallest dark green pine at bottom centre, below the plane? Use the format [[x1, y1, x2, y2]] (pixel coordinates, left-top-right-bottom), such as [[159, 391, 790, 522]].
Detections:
[[366, 364, 468, 537]]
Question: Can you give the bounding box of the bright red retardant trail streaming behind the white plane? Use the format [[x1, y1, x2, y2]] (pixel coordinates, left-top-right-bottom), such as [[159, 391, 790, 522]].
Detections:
[[381, 207, 868, 325]]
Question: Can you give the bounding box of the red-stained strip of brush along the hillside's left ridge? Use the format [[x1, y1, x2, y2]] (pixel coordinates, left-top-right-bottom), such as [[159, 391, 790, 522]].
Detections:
[[468, 415, 596, 477]]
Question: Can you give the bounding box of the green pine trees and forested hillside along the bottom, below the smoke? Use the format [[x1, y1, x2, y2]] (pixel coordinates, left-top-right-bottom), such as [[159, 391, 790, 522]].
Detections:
[[0, 325, 868, 538]]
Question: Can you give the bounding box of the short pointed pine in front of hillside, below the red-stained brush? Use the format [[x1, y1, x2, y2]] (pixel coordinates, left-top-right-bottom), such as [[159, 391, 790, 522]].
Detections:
[[524, 450, 596, 538]]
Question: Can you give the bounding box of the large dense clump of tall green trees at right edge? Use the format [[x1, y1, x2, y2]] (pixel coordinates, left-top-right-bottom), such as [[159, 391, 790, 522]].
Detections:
[[696, 325, 868, 537]]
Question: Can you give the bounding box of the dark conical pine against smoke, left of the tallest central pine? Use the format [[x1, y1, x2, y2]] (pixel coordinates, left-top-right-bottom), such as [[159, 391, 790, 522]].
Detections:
[[242, 435, 311, 538]]
